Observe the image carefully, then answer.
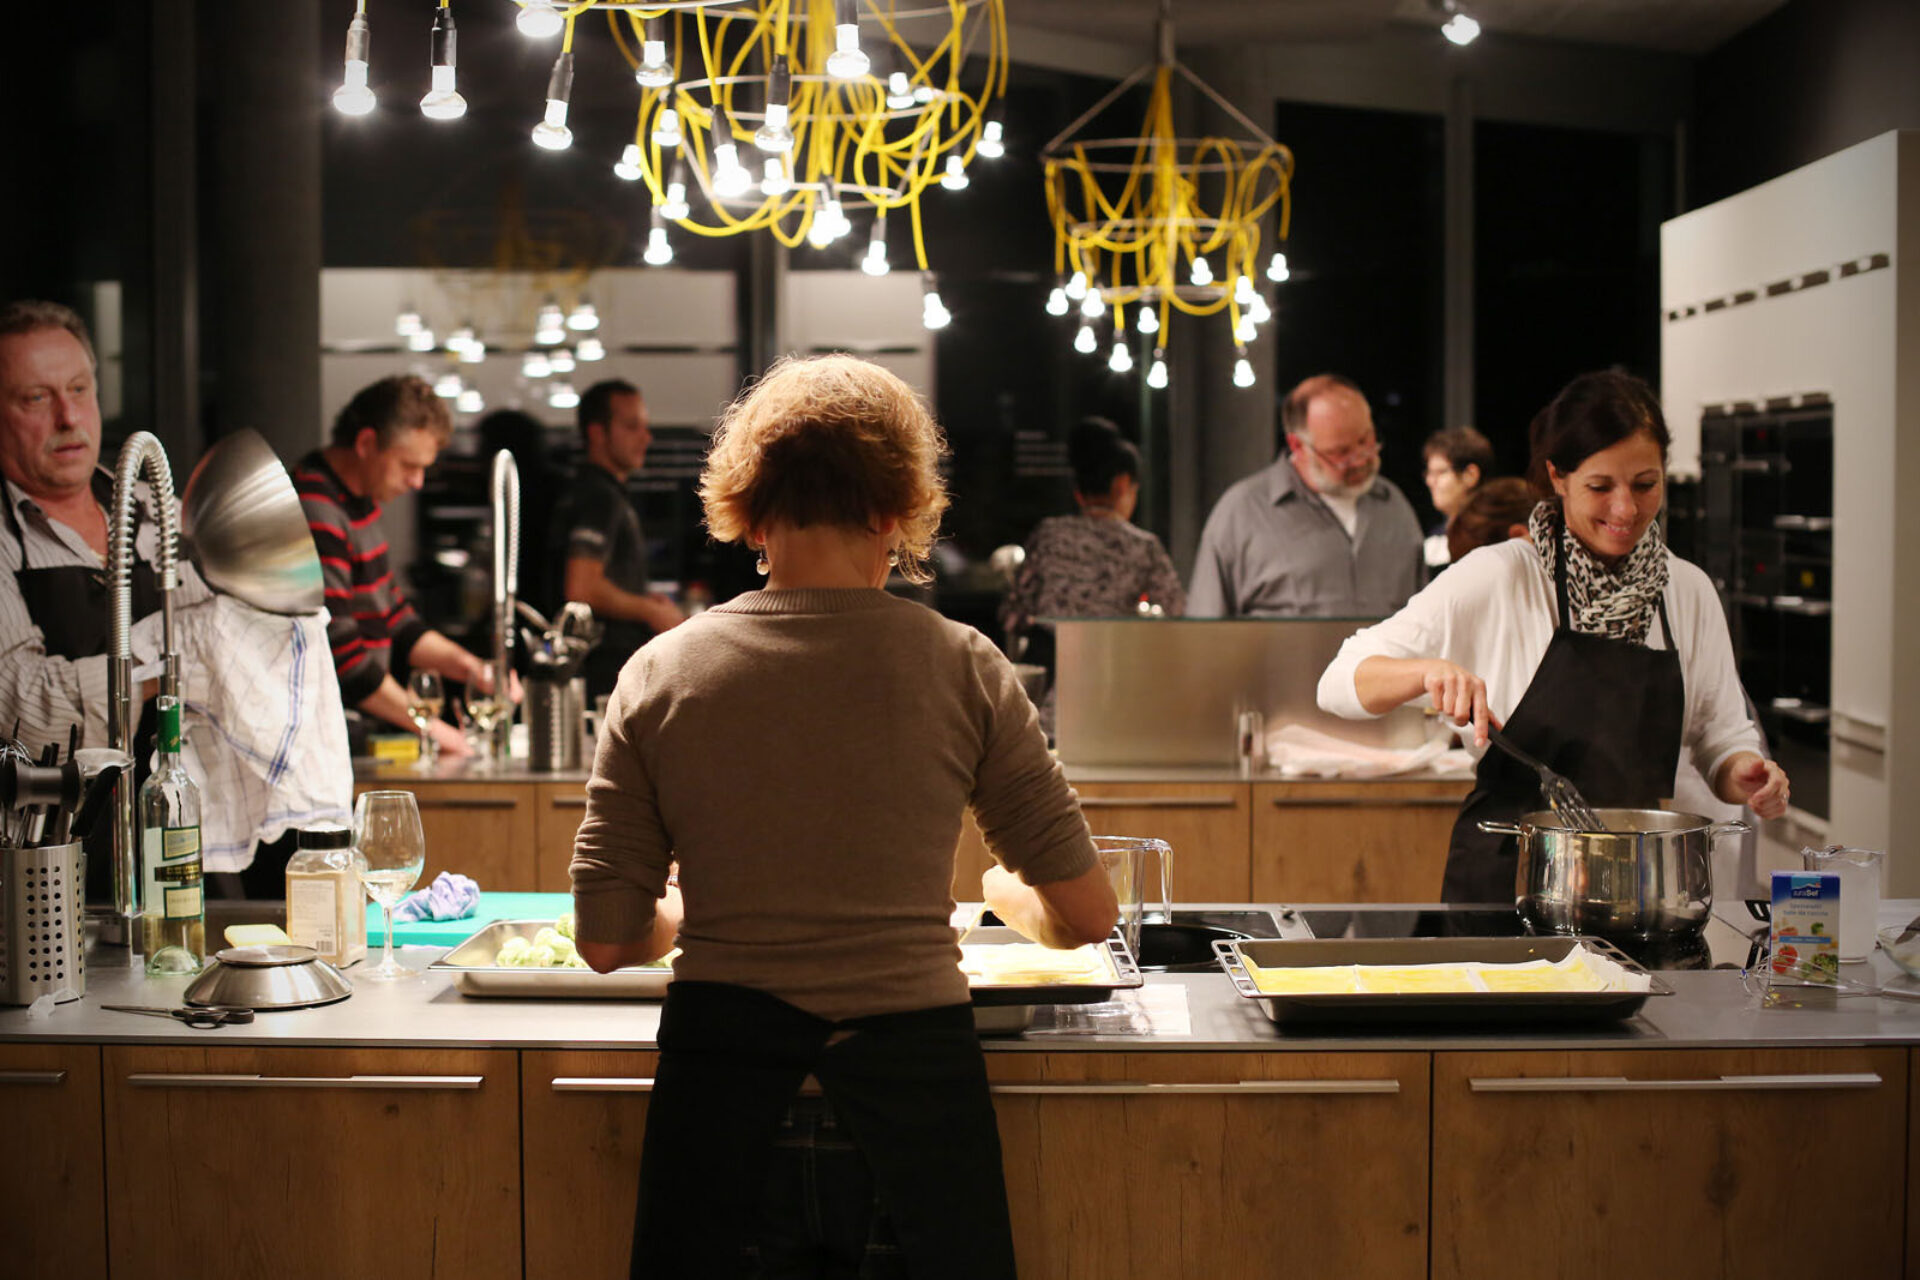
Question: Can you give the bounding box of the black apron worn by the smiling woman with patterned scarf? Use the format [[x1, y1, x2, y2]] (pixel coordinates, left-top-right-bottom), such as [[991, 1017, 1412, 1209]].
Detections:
[[1440, 557, 1686, 904]]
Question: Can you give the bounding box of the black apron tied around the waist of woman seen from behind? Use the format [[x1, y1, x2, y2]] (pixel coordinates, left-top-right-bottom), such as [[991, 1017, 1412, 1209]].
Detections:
[[632, 983, 1014, 1280]]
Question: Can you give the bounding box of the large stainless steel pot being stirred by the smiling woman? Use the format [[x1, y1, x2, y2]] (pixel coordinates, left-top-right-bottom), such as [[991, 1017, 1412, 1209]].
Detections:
[[1480, 810, 1747, 942]]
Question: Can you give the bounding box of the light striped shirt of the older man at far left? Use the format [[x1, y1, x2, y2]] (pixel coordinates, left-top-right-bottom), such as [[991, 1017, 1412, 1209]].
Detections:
[[0, 468, 211, 750]]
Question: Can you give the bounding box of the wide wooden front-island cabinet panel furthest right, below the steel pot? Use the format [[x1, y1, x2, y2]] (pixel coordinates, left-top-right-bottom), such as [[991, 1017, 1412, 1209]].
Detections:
[[1432, 1050, 1910, 1280]]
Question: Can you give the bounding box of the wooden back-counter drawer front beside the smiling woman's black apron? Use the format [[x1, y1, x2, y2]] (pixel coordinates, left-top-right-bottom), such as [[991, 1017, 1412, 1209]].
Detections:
[[1252, 781, 1471, 902]]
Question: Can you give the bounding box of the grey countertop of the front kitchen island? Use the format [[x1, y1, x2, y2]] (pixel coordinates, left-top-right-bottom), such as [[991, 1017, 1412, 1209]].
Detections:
[[15, 902, 1920, 1052]]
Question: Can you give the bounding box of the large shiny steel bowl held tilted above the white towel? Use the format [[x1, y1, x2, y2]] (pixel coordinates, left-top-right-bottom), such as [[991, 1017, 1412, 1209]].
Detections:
[[180, 430, 324, 614]]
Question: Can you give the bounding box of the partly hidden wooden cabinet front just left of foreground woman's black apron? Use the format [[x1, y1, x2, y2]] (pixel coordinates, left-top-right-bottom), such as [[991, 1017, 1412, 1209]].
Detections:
[[520, 1052, 660, 1280]]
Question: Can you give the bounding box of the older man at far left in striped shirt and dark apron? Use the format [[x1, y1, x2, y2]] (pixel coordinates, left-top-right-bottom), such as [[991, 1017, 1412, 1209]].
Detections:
[[0, 301, 207, 747]]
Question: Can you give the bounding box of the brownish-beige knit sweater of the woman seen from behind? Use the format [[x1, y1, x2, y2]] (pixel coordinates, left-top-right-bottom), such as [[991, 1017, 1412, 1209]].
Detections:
[[572, 589, 1096, 1021]]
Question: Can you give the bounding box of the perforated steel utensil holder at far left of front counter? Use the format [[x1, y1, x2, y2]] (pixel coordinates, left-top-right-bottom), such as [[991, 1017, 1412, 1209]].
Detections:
[[0, 841, 86, 1004]]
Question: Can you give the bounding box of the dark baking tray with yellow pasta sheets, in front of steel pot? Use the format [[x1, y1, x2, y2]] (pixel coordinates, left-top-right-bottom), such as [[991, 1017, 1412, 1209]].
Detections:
[[1213, 936, 1674, 1027]]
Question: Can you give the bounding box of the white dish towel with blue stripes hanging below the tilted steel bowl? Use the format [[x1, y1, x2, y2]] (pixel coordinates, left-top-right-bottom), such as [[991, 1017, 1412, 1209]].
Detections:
[[145, 595, 353, 871]]
